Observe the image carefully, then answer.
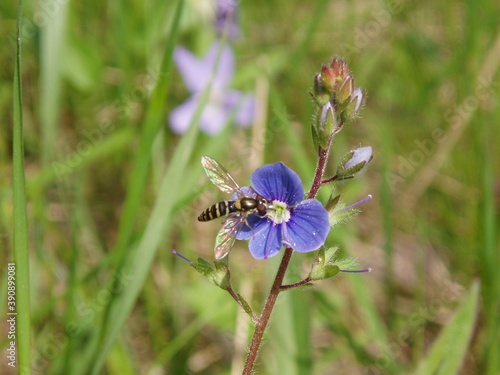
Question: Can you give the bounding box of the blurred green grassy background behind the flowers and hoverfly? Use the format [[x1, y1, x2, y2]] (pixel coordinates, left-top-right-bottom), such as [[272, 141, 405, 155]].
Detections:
[[0, 0, 500, 375]]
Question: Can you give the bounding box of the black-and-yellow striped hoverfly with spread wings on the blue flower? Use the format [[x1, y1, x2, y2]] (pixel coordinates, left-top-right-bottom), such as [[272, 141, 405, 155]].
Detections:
[[198, 156, 270, 259]]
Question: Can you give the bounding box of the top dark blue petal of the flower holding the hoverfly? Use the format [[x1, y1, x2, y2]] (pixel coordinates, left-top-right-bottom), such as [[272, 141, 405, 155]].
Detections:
[[250, 162, 304, 206]]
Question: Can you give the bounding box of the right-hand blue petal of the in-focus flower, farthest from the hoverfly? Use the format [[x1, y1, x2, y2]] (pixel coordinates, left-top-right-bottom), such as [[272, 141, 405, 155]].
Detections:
[[283, 199, 330, 253]]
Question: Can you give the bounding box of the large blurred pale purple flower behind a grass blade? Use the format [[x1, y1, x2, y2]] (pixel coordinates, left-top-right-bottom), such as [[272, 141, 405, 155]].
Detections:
[[169, 42, 254, 135]]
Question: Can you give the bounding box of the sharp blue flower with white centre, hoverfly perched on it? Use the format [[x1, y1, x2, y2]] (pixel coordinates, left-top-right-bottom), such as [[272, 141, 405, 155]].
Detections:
[[236, 162, 330, 259]]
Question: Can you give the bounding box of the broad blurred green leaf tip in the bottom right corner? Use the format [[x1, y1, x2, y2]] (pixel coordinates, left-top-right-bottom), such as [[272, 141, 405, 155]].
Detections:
[[415, 282, 479, 375]]
